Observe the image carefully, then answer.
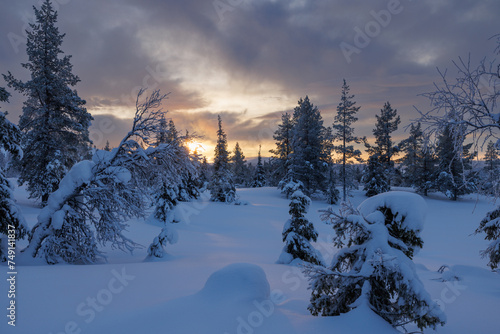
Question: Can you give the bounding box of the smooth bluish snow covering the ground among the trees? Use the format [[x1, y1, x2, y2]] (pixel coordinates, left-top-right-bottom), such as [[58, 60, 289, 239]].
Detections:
[[0, 188, 500, 334]]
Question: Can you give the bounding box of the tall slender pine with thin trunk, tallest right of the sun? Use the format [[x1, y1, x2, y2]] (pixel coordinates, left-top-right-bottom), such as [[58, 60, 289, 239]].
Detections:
[[332, 79, 366, 201]]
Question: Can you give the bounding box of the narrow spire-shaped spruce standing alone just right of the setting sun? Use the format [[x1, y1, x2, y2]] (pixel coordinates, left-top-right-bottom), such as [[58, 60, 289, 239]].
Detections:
[[208, 115, 237, 203]]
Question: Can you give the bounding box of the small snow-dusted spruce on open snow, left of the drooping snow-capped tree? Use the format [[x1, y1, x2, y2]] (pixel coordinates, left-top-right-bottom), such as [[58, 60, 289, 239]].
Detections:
[[278, 190, 324, 265]]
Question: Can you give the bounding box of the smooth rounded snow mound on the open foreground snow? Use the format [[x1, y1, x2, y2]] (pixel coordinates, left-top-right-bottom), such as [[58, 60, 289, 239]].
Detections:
[[200, 263, 270, 301]]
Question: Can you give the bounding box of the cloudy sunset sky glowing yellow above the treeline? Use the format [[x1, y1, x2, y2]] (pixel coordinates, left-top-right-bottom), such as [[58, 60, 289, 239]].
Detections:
[[0, 0, 500, 162]]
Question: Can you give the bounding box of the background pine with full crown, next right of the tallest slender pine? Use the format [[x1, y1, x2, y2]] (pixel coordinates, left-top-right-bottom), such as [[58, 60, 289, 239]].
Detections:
[[366, 102, 401, 186]]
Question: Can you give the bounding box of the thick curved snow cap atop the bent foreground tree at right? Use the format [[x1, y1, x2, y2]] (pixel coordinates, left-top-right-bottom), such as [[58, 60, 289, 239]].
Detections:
[[358, 191, 427, 231]]
